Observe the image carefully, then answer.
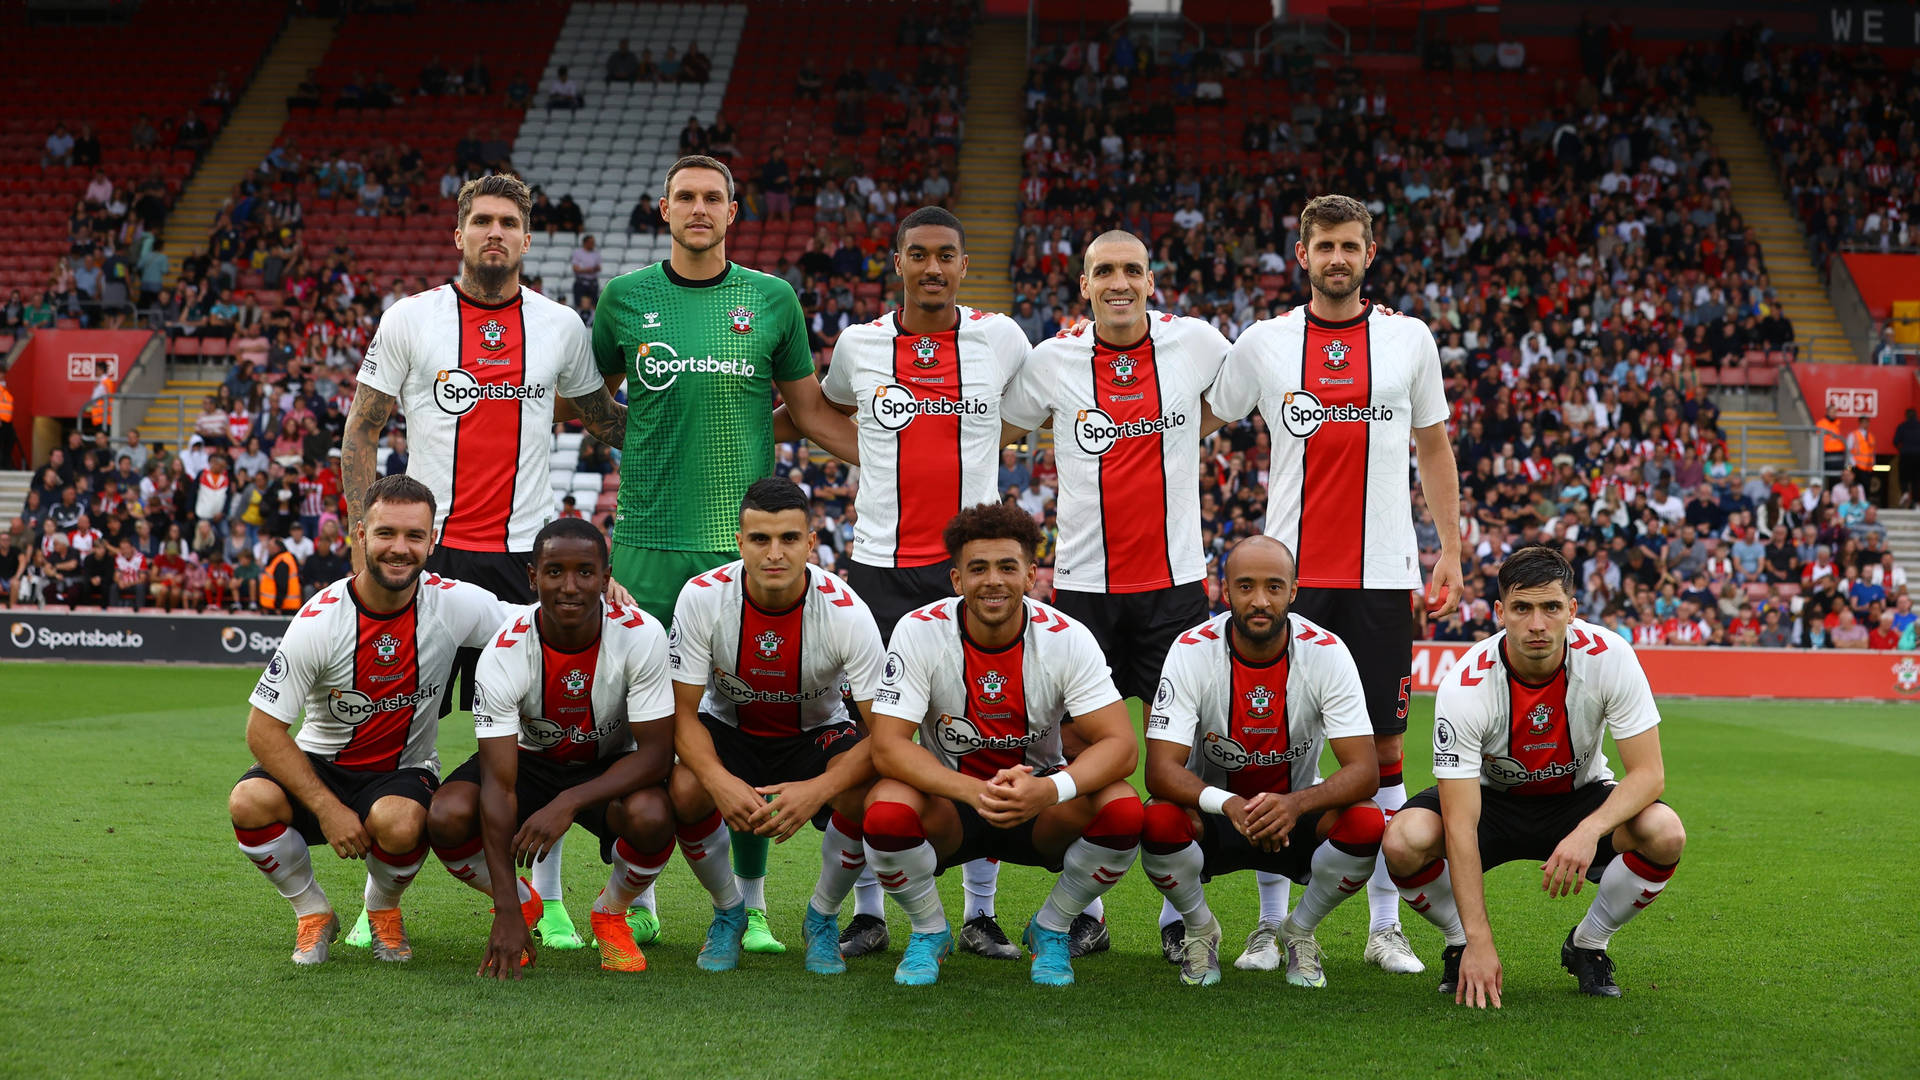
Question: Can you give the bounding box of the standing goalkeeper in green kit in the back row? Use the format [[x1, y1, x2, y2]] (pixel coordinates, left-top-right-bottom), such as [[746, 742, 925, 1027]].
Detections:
[[593, 156, 856, 953]]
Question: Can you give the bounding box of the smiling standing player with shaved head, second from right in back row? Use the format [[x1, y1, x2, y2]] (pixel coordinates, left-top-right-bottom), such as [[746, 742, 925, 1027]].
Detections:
[[1000, 231, 1236, 953]]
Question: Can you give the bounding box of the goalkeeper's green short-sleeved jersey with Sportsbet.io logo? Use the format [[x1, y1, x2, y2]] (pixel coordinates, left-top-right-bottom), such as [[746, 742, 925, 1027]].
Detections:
[[593, 261, 814, 552]]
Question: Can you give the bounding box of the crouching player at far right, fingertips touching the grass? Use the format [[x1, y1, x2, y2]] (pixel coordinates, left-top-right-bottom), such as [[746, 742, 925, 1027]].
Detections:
[[1384, 548, 1686, 1009]]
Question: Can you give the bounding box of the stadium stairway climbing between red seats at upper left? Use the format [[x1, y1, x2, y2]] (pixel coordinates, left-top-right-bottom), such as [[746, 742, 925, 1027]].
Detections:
[[161, 17, 334, 286]]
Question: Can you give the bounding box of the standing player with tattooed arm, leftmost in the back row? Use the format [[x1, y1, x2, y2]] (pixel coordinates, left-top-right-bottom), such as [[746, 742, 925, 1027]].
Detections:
[[340, 175, 633, 949]]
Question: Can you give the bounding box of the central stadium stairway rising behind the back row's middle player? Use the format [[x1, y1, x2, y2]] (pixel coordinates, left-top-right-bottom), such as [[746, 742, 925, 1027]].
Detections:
[[954, 21, 1027, 311]]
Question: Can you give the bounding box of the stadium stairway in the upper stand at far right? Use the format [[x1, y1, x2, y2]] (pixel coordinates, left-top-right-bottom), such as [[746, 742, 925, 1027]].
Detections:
[[1697, 94, 1859, 363]]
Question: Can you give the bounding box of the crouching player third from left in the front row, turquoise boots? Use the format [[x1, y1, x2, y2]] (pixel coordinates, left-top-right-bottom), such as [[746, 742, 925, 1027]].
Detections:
[[670, 479, 881, 974]]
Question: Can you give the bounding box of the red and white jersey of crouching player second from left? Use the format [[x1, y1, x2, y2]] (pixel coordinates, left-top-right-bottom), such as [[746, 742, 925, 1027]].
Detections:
[[474, 601, 674, 765]]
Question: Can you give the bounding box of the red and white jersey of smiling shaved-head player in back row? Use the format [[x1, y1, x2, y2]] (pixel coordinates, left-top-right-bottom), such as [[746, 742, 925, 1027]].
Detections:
[[1000, 311, 1227, 592]]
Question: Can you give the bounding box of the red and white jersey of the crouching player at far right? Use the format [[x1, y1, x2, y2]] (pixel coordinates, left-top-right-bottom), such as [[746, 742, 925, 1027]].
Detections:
[[1434, 619, 1661, 796]]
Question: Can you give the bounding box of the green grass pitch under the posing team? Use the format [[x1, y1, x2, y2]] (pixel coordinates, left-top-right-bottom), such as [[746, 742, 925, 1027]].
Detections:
[[0, 663, 1920, 1078]]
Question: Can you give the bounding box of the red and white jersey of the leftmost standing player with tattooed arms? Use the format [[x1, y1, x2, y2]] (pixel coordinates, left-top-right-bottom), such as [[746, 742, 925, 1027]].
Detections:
[[359, 284, 603, 552]]
